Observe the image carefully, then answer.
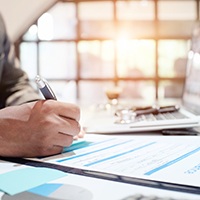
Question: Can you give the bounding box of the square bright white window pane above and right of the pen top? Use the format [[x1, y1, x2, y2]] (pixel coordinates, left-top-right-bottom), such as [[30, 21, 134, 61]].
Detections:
[[39, 42, 77, 79]]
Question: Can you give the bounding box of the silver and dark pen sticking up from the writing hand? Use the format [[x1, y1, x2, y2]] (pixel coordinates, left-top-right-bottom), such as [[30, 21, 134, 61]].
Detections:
[[35, 75, 57, 100]]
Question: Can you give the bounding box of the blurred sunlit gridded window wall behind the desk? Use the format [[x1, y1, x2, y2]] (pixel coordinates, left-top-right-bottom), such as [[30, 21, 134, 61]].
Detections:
[[0, 0, 200, 104]]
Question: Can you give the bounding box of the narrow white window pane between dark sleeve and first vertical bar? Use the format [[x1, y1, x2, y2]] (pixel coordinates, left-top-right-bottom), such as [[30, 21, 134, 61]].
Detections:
[[20, 42, 38, 79]]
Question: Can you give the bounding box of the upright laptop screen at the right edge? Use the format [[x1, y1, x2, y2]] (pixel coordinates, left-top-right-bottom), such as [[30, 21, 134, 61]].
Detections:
[[183, 24, 200, 114]]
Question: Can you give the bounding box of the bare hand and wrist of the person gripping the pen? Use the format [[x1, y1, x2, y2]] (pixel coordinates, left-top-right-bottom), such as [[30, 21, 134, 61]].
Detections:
[[0, 100, 80, 157]]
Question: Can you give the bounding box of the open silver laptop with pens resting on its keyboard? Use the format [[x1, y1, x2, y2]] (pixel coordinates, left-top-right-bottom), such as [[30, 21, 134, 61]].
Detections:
[[83, 24, 200, 133]]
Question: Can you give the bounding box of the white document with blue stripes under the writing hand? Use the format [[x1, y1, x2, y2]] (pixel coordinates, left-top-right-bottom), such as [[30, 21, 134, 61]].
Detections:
[[43, 134, 200, 187]]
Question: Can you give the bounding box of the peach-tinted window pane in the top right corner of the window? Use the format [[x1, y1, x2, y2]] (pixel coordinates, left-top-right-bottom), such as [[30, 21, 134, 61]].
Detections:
[[158, 0, 197, 20]]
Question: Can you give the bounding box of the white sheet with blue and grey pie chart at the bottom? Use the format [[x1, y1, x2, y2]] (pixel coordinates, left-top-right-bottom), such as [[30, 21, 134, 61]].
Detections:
[[0, 174, 200, 200]]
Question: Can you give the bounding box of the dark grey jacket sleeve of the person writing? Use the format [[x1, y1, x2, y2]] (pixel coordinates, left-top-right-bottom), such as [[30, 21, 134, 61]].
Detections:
[[0, 13, 41, 108]]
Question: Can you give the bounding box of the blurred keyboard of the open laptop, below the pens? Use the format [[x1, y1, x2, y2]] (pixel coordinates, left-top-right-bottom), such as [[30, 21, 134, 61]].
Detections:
[[134, 111, 188, 121]]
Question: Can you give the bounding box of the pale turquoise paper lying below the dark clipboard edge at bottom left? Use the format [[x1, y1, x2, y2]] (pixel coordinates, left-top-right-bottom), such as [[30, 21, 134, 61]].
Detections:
[[0, 161, 66, 195]]
